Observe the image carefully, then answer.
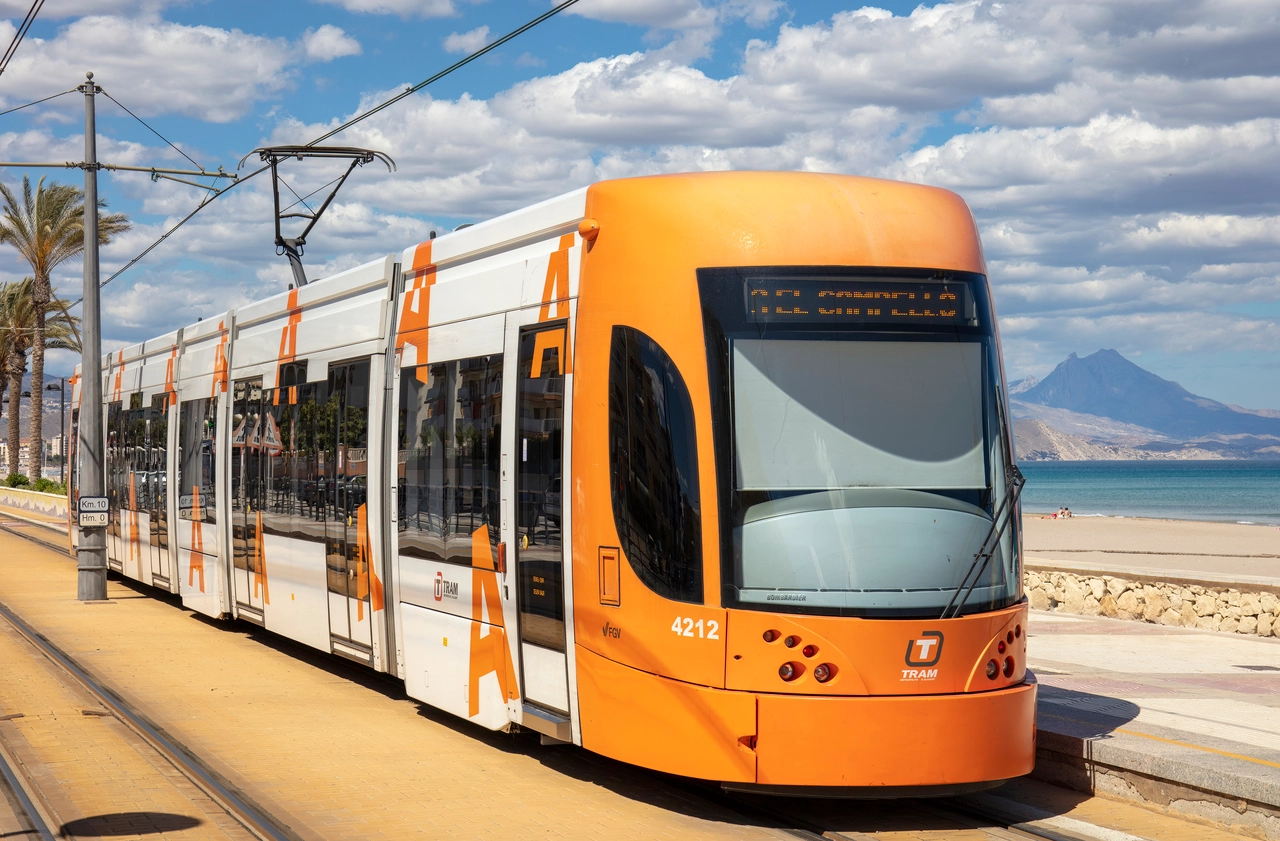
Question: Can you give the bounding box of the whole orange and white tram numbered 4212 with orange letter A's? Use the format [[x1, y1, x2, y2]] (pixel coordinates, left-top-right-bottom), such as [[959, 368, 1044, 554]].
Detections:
[[70, 173, 1036, 796]]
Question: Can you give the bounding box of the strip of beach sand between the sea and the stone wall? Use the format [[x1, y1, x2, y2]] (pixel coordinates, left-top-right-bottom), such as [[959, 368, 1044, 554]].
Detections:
[[1023, 513, 1280, 580]]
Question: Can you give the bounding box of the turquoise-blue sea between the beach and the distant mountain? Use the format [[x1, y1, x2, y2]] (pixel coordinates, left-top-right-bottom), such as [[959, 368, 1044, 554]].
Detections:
[[1018, 461, 1280, 525]]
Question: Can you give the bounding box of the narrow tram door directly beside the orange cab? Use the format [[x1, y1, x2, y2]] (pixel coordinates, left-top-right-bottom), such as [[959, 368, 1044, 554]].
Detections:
[[515, 321, 568, 714]]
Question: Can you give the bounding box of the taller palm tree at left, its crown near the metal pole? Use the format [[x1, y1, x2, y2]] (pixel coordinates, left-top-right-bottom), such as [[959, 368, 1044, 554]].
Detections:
[[0, 175, 131, 481]]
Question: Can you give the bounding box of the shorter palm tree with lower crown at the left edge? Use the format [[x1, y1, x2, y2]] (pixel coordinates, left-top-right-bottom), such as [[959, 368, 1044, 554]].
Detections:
[[0, 278, 81, 477]]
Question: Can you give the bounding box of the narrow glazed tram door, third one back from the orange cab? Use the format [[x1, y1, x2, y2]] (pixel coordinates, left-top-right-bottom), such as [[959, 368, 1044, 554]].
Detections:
[[230, 378, 266, 625]]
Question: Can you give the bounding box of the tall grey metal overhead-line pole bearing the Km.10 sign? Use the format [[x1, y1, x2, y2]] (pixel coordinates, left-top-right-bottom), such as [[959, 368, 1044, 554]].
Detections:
[[76, 73, 106, 602]]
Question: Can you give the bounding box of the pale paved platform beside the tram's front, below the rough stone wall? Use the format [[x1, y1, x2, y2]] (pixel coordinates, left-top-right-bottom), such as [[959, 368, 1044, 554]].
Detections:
[[1028, 612, 1280, 838]]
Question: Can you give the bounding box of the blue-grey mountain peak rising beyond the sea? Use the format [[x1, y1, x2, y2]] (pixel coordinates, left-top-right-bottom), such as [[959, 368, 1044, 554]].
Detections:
[[1019, 348, 1280, 438]]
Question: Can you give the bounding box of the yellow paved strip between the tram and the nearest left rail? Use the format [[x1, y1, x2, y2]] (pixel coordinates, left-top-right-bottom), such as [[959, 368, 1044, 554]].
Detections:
[[0, 533, 780, 840]]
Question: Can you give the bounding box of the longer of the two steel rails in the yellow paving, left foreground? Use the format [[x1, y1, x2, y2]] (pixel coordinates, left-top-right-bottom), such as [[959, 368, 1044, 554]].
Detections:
[[0, 596, 301, 841]]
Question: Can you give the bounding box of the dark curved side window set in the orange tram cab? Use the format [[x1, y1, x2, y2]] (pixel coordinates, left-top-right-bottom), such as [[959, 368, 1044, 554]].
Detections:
[[609, 326, 703, 604]]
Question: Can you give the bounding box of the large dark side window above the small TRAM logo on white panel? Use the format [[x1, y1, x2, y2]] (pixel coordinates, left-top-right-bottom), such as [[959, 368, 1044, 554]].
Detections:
[[397, 353, 502, 566]]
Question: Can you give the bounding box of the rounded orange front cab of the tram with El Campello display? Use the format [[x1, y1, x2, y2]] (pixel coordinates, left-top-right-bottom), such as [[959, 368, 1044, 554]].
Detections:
[[568, 173, 1036, 796]]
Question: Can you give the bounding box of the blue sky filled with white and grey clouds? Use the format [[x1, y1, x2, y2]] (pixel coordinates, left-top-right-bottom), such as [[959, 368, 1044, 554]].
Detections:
[[0, 0, 1280, 408]]
